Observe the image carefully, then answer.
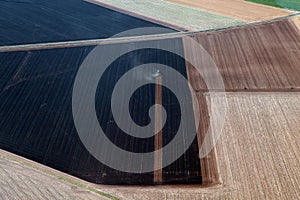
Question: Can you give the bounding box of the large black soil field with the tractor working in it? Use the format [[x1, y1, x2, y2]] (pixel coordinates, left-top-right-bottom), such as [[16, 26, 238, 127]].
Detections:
[[0, 39, 201, 184]]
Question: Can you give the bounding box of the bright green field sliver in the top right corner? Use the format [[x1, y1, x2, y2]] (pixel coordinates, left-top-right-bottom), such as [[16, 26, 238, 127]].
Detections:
[[246, 0, 300, 11]]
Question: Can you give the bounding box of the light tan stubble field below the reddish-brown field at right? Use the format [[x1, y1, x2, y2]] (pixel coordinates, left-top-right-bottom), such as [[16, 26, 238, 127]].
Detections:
[[214, 93, 300, 199]]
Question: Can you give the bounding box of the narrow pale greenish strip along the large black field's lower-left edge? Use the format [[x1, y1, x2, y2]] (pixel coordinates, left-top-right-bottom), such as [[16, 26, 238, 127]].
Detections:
[[0, 152, 119, 200]]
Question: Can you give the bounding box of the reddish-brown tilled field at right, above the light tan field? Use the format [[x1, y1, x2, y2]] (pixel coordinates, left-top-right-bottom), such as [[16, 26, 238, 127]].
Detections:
[[185, 17, 300, 91]]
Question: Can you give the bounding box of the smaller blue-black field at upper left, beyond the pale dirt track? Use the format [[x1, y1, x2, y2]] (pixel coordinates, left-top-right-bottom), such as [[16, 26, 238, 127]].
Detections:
[[0, 0, 173, 45]]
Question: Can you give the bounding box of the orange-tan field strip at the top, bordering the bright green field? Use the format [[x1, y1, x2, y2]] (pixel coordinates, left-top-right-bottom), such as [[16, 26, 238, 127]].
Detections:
[[167, 0, 291, 22]]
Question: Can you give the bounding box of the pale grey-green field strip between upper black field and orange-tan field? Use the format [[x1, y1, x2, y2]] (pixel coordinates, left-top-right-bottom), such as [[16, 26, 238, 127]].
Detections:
[[86, 0, 247, 31]]
